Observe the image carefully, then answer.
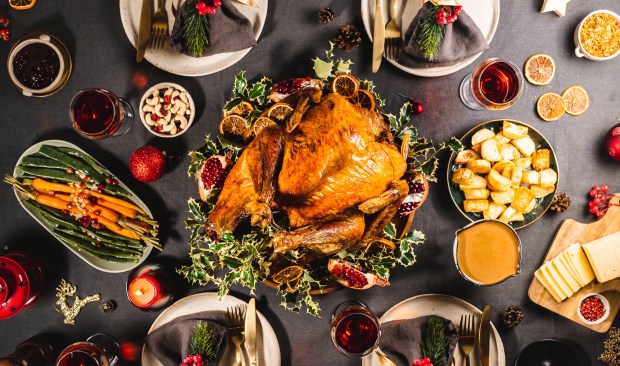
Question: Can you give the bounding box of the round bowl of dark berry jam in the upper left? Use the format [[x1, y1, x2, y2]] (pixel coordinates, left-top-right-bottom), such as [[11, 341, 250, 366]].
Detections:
[[7, 34, 71, 97]]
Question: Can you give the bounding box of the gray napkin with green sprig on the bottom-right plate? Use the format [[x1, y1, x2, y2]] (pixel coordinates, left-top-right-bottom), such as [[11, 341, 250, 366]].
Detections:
[[379, 316, 463, 366]]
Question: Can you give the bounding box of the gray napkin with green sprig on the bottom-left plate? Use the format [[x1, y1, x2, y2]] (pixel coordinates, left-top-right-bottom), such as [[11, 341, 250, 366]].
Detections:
[[145, 311, 227, 366]]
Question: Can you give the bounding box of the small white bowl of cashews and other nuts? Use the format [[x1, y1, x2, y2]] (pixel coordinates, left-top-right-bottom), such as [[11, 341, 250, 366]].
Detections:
[[140, 83, 196, 138]]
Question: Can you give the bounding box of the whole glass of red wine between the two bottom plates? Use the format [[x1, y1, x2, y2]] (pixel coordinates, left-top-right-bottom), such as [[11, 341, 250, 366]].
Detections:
[[331, 301, 381, 358]]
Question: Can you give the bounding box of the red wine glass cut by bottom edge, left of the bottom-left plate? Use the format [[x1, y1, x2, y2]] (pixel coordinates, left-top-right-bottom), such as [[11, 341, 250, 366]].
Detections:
[[56, 333, 120, 366]]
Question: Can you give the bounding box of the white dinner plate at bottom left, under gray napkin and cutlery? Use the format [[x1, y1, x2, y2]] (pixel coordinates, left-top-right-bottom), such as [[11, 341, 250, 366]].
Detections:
[[142, 292, 280, 366]]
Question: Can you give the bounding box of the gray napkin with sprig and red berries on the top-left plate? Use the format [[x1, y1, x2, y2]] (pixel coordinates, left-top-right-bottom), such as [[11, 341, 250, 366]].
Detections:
[[170, 0, 256, 57]]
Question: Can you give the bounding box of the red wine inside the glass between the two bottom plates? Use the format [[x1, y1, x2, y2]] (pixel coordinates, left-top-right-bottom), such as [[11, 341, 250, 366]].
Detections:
[[336, 313, 379, 353]]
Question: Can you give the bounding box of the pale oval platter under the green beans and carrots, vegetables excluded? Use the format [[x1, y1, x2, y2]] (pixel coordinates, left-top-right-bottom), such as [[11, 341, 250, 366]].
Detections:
[[13, 140, 153, 273]]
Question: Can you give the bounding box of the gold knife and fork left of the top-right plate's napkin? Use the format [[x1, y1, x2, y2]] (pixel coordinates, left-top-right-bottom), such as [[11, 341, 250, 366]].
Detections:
[[372, 0, 403, 72]]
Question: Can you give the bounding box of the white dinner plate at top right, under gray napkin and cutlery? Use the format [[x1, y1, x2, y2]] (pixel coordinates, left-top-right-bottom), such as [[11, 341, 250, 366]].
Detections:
[[362, 0, 499, 77]]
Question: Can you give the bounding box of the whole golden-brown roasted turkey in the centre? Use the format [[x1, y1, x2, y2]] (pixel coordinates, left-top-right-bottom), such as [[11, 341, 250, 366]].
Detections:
[[205, 93, 409, 258]]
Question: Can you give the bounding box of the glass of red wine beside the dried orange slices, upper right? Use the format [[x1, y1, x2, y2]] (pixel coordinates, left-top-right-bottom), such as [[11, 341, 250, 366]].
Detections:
[[460, 58, 523, 111]]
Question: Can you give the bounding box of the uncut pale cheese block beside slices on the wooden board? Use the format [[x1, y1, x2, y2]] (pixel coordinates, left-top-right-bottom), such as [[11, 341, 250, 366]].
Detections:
[[582, 232, 620, 283]]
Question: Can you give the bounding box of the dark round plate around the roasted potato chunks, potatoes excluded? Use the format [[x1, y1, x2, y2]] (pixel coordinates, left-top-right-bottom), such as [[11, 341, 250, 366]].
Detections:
[[447, 119, 560, 230]]
